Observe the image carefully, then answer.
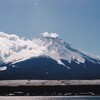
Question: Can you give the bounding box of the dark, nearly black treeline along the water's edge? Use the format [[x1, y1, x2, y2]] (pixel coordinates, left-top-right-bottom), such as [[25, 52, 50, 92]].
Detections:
[[0, 85, 100, 96]]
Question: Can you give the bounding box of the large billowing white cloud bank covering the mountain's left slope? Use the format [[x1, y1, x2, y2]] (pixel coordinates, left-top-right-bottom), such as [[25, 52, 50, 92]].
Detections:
[[0, 32, 45, 64]]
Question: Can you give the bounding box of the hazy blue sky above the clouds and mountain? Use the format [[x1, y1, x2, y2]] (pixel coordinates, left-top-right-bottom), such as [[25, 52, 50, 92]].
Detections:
[[0, 0, 100, 56]]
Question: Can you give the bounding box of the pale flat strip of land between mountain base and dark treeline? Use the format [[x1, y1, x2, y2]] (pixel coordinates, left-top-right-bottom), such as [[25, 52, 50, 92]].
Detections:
[[0, 80, 100, 86]]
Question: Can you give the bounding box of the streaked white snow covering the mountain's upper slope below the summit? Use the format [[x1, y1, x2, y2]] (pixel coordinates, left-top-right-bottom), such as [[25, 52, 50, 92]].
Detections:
[[37, 36, 85, 68]]
